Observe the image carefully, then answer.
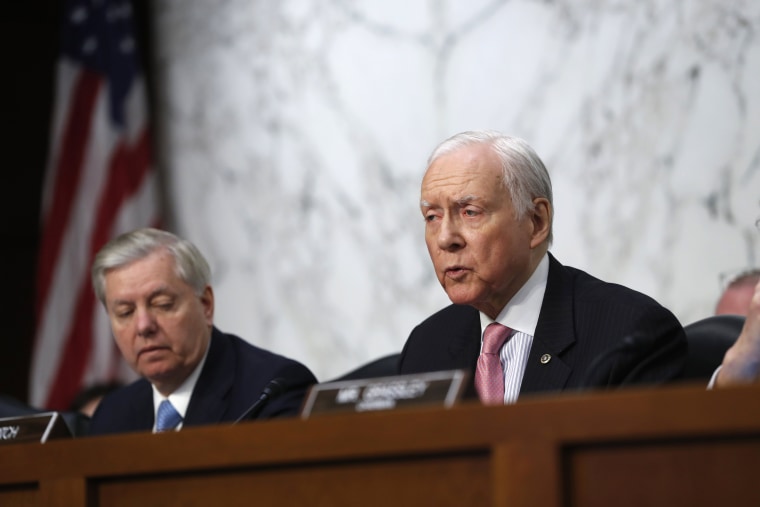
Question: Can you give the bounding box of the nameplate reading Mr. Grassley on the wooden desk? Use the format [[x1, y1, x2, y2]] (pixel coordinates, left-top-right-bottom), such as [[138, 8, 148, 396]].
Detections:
[[301, 370, 468, 419]]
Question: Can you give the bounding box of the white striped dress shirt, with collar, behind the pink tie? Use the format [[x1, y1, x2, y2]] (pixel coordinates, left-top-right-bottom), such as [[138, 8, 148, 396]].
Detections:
[[480, 255, 549, 403]]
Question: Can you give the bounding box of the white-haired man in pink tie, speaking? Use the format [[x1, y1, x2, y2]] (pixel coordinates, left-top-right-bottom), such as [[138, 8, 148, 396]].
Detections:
[[400, 131, 687, 404]]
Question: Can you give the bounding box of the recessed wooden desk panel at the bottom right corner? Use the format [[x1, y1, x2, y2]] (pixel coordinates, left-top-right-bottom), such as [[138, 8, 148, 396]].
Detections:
[[565, 435, 760, 507]]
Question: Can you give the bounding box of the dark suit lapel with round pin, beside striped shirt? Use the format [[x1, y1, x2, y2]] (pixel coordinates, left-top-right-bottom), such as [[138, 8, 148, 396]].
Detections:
[[520, 254, 575, 395]]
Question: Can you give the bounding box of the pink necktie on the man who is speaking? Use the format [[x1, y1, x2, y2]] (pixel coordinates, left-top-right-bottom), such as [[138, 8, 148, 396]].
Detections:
[[475, 322, 512, 405]]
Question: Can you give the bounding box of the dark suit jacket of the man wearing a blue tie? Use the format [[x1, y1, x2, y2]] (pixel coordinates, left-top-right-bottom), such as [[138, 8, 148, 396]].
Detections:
[[89, 328, 317, 435]]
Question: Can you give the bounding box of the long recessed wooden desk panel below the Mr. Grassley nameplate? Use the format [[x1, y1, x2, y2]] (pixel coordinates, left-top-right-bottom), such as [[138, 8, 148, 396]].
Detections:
[[95, 454, 491, 507]]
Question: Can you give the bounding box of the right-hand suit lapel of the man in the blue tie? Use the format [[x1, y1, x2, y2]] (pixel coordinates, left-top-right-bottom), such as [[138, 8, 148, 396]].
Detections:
[[184, 328, 235, 426]]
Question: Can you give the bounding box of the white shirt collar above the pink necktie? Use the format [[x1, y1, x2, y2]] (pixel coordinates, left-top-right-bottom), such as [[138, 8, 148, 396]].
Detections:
[[480, 254, 549, 336]]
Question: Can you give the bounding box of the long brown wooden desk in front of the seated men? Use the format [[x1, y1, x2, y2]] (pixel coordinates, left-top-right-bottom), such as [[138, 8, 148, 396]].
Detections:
[[0, 386, 760, 507]]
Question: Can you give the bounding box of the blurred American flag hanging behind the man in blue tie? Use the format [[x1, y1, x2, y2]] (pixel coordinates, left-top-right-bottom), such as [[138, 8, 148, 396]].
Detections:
[[29, 0, 160, 410]]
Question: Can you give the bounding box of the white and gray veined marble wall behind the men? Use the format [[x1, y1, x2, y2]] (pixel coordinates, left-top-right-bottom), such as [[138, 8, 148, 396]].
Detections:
[[153, 0, 760, 380]]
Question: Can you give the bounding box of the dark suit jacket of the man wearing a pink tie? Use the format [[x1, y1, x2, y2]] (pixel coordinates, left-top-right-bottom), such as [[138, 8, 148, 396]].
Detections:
[[399, 254, 687, 397]]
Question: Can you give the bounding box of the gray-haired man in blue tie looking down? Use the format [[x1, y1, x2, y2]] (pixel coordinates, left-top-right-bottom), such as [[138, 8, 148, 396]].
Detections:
[[90, 228, 316, 435]]
